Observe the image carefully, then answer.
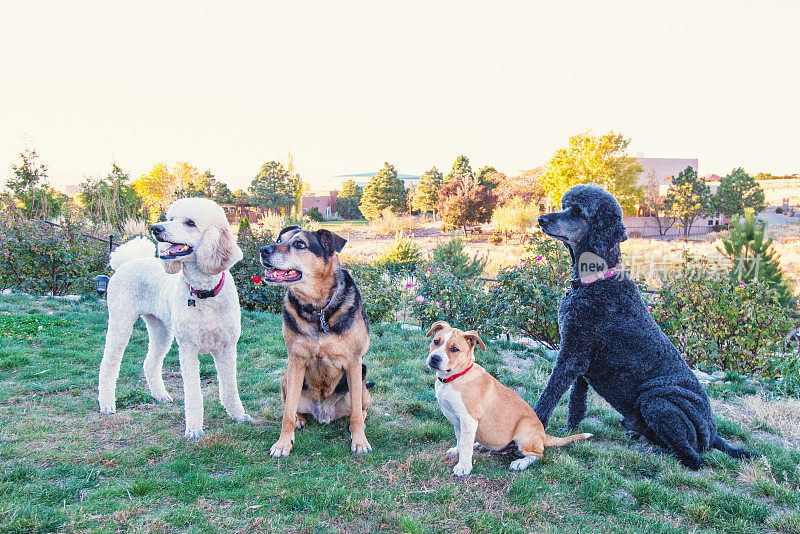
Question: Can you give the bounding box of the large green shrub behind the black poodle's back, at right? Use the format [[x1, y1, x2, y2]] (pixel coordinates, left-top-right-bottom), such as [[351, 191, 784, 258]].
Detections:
[[652, 252, 792, 373]]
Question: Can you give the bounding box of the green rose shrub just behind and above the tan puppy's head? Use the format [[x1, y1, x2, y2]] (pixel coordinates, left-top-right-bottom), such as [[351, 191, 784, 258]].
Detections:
[[412, 265, 492, 333]]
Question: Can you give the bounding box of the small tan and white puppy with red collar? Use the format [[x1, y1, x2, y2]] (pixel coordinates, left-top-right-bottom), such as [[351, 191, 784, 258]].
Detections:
[[426, 321, 592, 476]]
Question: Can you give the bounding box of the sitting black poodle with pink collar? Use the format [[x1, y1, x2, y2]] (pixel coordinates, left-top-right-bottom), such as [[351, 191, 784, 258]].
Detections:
[[534, 185, 750, 469]]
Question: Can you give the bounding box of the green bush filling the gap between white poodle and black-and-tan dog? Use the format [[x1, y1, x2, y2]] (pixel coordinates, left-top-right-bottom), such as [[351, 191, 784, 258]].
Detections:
[[231, 224, 286, 313]]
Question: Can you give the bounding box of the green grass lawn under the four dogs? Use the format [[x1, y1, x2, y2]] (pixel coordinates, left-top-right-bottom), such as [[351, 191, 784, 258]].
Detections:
[[0, 296, 800, 533]]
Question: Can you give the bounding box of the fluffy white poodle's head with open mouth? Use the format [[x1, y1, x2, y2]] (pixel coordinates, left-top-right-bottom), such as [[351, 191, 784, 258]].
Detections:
[[150, 198, 242, 274]]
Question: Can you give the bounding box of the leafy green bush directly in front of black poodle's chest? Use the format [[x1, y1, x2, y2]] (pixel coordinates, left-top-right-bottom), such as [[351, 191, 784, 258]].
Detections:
[[489, 233, 570, 347]]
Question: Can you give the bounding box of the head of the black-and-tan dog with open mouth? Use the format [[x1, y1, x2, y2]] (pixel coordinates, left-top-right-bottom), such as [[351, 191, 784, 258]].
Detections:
[[261, 226, 347, 289]]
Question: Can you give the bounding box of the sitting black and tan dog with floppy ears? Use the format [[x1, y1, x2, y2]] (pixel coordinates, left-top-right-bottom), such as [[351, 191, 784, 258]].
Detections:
[[261, 226, 372, 457]]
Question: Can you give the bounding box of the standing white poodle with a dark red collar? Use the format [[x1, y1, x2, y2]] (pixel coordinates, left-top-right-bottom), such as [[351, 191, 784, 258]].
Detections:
[[98, 198, 252, 438]]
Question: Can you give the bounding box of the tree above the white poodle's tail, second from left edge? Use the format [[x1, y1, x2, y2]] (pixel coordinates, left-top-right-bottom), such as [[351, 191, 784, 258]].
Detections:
[[78, 163, 143, 230]]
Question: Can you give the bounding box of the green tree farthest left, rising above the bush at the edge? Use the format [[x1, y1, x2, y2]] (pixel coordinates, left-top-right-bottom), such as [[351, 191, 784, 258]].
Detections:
[[6, 149, 69, 219]]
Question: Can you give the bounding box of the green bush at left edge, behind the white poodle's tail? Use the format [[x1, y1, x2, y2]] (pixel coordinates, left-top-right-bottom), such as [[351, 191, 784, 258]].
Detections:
[[0, 217, 108, 295]]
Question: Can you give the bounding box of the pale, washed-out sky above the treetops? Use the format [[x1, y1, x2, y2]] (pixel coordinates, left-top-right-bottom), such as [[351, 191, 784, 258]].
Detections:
[[0, 0, 800, 193]]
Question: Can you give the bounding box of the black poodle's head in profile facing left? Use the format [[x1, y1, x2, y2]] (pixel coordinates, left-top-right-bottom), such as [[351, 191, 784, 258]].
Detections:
[[539, 184, 628, 265]]
